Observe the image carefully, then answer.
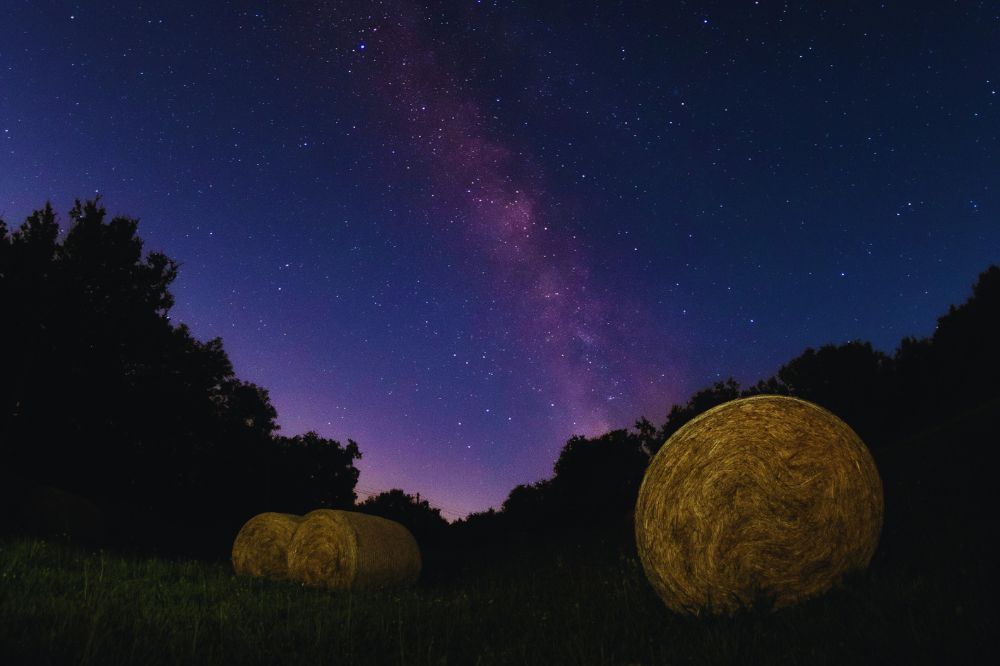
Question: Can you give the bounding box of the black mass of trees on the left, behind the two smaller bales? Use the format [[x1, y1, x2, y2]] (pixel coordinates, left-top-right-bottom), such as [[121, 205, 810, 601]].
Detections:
[[0, 200, 360, 550]]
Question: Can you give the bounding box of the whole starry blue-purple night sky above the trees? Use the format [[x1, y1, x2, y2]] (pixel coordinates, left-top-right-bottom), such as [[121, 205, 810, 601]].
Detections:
[[0, 0, 1000, 518]]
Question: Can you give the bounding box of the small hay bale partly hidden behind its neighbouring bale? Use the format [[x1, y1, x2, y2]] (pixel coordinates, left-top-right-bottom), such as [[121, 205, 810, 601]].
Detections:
[[233, 512, 302, 579]]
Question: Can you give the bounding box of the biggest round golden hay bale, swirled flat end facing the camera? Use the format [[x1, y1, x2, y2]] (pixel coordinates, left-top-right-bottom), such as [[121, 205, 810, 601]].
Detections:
[[635, 395, 883, 614]]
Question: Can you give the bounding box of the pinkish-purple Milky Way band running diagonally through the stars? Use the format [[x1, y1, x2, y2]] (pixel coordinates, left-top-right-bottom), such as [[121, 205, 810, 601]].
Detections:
[[282, 3, 682, 488]]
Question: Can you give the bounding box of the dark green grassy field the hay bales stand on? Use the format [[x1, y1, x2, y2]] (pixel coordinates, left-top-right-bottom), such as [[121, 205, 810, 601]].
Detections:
[[0, 528, 995, 664]]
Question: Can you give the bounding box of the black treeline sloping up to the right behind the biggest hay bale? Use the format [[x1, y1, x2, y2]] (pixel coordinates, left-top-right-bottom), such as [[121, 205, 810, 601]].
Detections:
[[454, 265, 1000, 559]]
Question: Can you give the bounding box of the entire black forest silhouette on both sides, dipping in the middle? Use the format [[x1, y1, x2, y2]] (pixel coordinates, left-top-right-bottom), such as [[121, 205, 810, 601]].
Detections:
[[0, 199, 1000, 574]]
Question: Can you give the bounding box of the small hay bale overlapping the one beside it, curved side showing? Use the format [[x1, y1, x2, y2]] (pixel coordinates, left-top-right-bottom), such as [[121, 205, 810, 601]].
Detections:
[[288, 509, 421, 590]]
